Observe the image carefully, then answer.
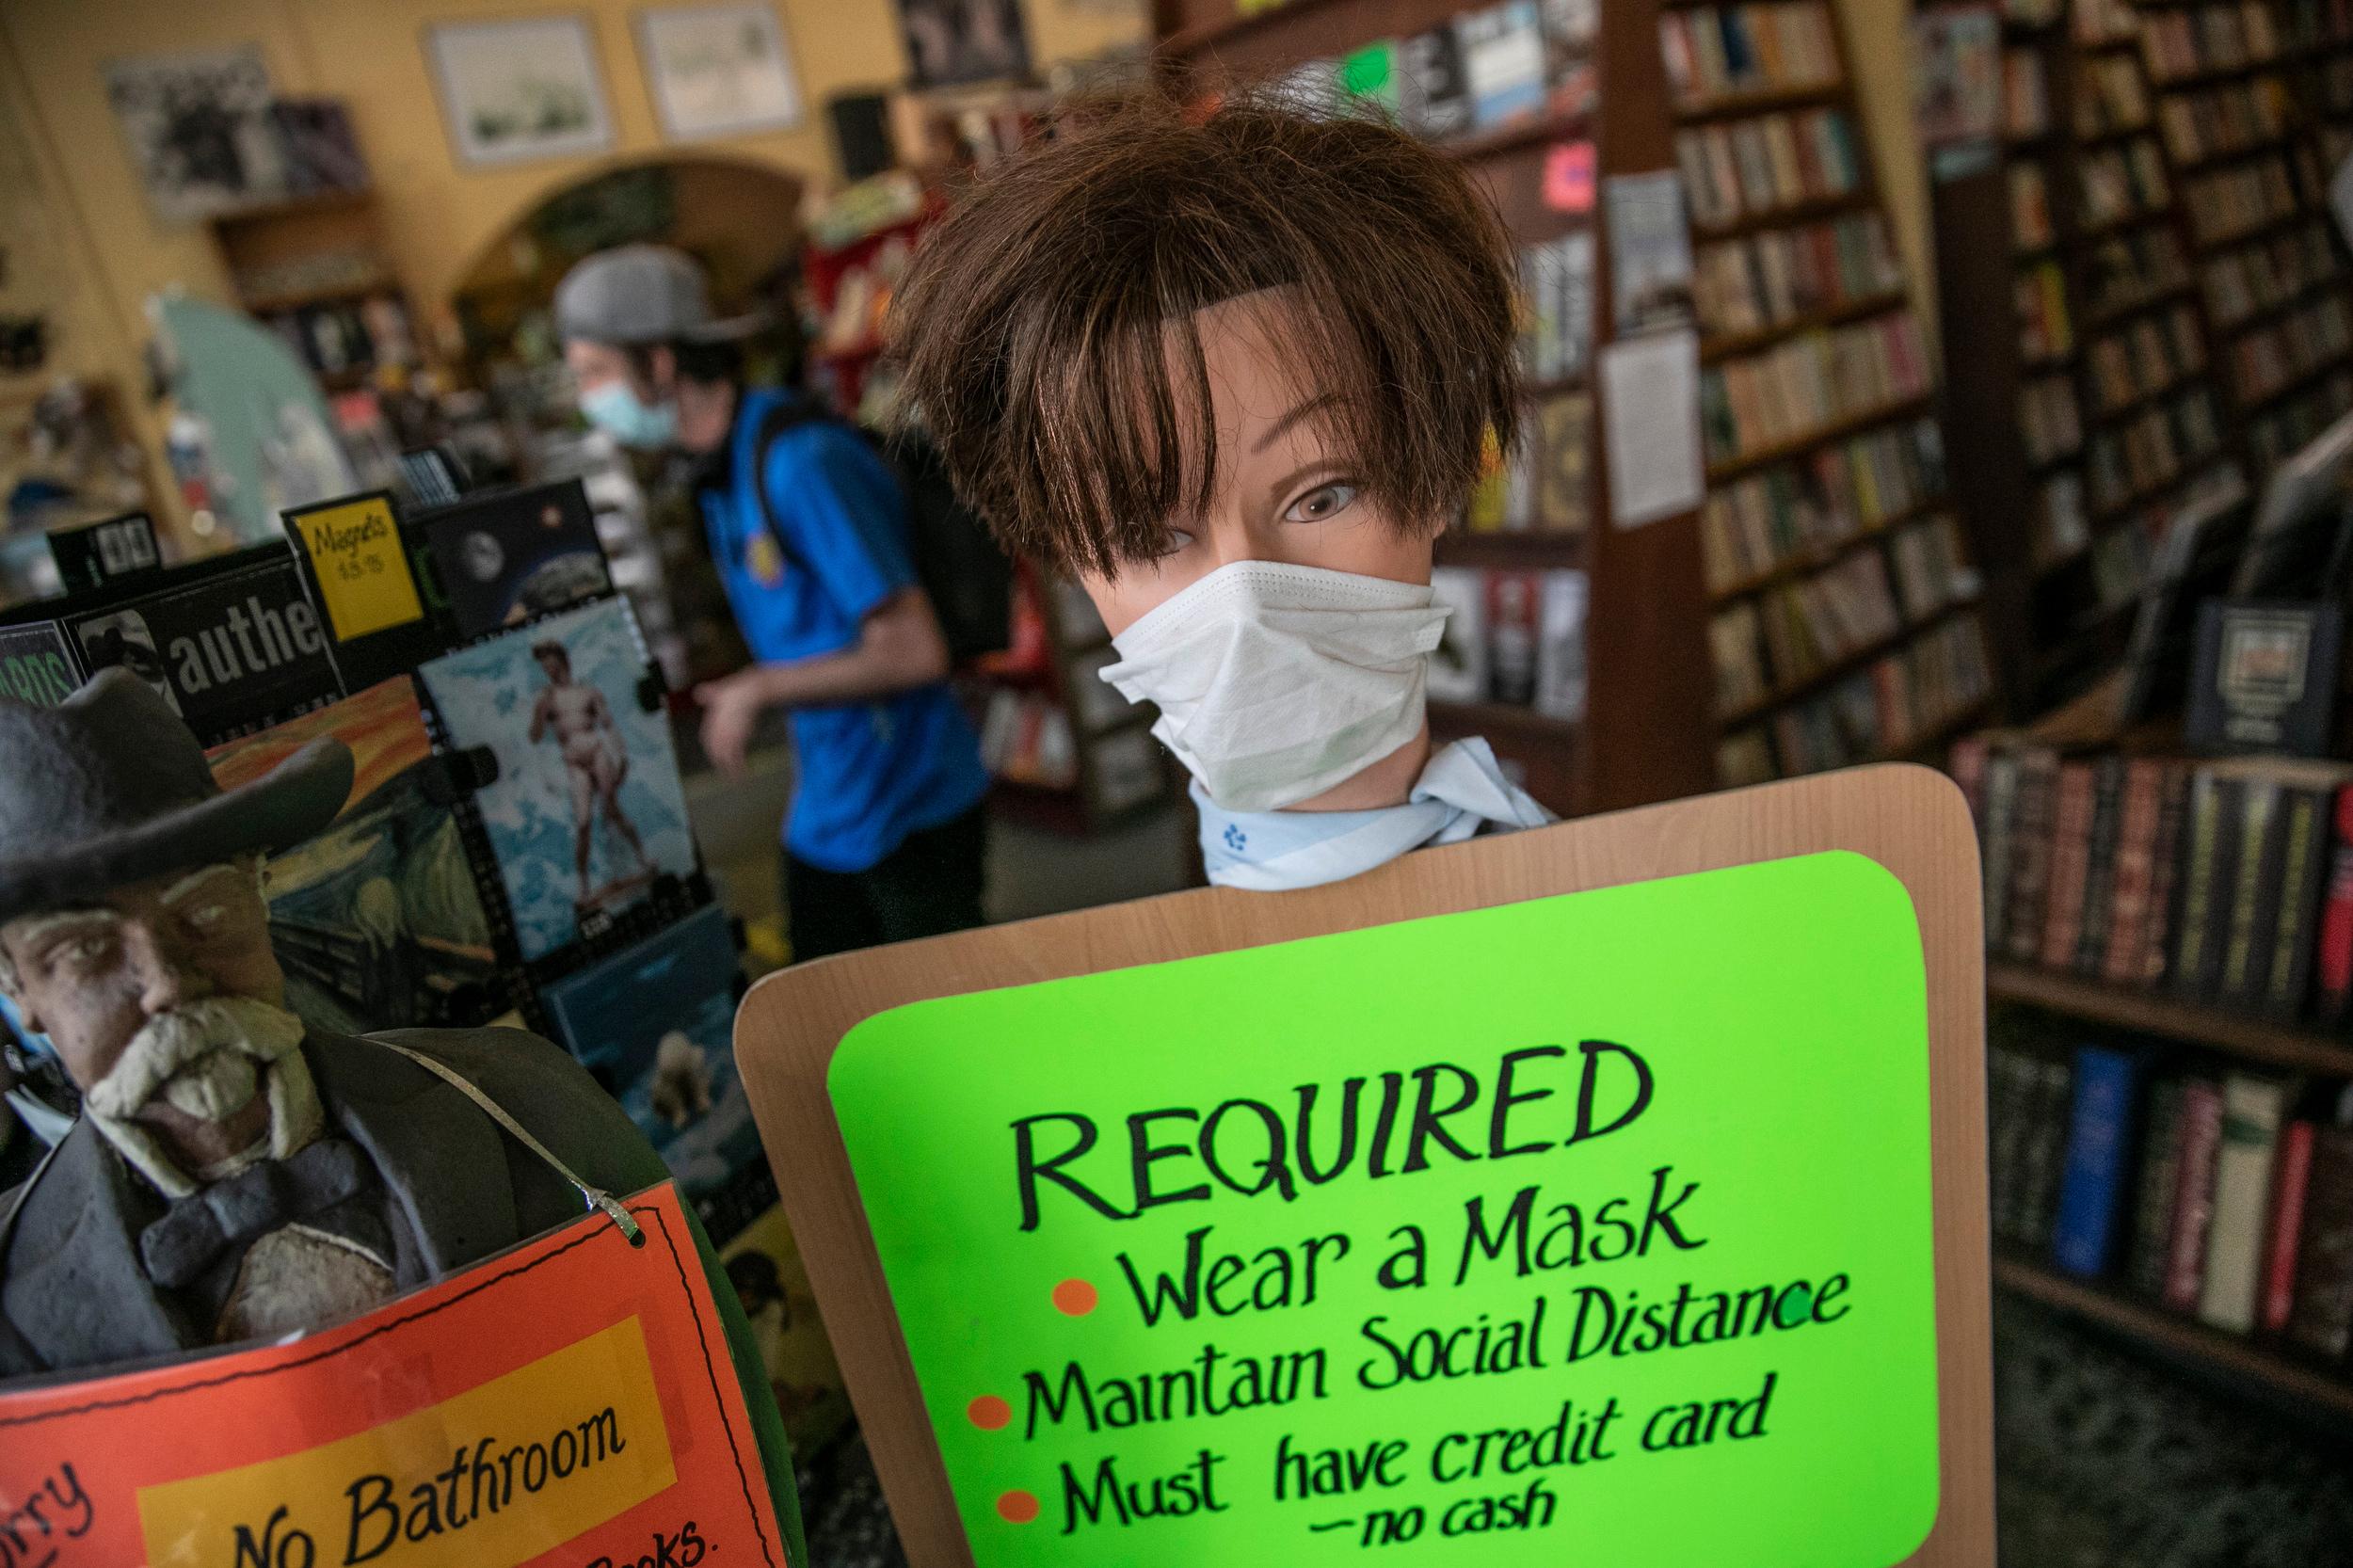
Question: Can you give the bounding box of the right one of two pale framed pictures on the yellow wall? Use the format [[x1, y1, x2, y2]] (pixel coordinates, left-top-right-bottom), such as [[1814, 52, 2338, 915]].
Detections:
[[638, 3, 800, 141]]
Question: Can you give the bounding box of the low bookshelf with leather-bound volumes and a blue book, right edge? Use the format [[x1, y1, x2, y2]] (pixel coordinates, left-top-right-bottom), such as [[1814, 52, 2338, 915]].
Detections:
[[1951, 720, 2353, 1422]]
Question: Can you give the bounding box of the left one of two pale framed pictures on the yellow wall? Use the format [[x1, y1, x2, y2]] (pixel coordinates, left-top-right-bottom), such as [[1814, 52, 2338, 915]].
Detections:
[[426, 17, 612, 165]]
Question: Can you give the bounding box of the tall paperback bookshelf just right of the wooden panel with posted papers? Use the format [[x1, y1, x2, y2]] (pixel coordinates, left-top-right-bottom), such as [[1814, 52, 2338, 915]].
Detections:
[[1659, 0, 1993, 784]]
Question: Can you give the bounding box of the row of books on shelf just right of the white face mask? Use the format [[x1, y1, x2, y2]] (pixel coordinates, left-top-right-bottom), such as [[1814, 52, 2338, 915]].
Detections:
[[1429, 568, 1586, 723]]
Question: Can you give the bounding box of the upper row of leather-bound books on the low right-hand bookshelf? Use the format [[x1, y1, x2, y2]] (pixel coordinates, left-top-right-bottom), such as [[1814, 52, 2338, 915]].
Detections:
[[1951, 734, 2353, 1024]]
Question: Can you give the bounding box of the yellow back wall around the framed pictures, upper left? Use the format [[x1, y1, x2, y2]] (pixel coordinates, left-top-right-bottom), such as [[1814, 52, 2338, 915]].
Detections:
[[0, 0, 1144, 353]]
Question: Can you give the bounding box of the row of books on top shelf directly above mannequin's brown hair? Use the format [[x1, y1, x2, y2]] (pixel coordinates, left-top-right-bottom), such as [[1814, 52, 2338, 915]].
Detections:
[[1278, 0, 1600, 141]]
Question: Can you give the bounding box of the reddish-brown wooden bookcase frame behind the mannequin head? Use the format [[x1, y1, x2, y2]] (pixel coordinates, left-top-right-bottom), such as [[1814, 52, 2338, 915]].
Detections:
[[1153, 0, 1732, 815]]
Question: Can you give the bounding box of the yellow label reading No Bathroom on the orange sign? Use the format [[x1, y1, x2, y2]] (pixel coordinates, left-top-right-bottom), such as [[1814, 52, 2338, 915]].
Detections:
[[139, 1316, 676, 1568]]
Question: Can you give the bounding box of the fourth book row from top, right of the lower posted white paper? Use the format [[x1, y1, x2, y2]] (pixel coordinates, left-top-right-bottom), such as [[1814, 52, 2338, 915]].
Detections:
[[1699, 311, 1929, 461]]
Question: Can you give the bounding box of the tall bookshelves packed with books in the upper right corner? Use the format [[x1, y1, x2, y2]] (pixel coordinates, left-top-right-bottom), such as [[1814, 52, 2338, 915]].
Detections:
[[1932, 0, 2353, 711]]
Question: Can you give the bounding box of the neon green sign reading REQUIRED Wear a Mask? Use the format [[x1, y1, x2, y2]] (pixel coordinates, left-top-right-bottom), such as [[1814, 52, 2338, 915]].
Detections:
[[831, 853, 1937, 1568]]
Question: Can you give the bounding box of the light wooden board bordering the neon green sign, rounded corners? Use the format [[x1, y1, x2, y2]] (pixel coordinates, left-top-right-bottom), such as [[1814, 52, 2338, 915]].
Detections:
[[737, 765, 1993, 1568]]
